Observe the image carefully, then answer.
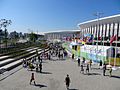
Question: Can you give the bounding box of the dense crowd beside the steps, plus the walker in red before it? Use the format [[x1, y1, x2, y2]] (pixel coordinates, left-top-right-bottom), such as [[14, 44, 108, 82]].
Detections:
[[23, 45, 67, 85]]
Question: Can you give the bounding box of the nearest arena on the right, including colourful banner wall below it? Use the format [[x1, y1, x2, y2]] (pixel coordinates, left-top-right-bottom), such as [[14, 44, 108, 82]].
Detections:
[[78, 14, 120, 66]]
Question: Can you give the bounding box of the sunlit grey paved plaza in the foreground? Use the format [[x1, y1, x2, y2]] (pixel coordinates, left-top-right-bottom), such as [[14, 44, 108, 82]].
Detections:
[[0, 59, 120, 90]]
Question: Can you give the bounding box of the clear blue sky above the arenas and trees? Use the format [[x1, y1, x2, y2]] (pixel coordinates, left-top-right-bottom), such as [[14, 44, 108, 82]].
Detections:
[[0, 0, 120, 33]]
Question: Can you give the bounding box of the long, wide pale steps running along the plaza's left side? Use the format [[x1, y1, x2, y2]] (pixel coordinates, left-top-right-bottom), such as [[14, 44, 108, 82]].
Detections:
[[0, 47, 49, 74]]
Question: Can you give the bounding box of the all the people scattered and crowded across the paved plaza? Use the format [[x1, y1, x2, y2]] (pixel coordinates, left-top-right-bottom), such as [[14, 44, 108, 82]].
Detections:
[[23, 45, 112, 89]]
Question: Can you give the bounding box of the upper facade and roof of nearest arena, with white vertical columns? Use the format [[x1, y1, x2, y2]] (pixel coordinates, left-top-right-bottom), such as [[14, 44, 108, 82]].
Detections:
[[78, 14, 120, 46]]
